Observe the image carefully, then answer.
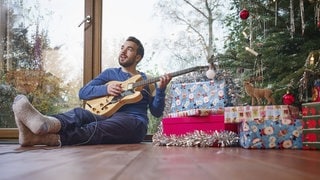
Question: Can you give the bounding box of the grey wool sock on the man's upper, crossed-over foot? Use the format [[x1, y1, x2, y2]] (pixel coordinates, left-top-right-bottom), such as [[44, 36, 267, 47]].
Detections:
[[12, 95, 61, 135]]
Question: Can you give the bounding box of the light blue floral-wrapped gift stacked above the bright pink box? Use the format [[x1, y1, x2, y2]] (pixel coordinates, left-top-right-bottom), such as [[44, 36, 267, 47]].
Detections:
[[170, 80, 226, 112]]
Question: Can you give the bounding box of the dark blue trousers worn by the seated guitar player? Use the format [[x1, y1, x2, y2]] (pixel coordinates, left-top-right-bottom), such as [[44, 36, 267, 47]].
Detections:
[[52, 108, 147, 146]]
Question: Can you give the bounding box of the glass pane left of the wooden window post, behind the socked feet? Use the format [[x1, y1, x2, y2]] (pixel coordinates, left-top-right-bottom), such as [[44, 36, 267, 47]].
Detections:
[[0, 0, 84, 128]]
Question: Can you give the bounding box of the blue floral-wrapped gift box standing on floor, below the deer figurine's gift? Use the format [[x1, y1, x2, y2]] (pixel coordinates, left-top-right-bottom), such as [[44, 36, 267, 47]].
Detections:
[[239, 119, 303, 149]]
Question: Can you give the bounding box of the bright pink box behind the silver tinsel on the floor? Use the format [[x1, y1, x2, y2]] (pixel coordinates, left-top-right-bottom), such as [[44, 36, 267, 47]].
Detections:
[[162, 114, 238, 135]]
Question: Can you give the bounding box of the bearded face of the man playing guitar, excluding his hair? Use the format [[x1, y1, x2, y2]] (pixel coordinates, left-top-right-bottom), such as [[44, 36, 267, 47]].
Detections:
[[118, 41, 141, 67]]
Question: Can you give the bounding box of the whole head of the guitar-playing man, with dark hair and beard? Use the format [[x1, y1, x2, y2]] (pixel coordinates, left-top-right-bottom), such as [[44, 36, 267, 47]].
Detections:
[[119, 36, 144, 67]]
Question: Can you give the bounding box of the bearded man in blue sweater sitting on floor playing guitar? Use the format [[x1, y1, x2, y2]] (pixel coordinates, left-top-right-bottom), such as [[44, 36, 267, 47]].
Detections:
[[12, 37, 171, 146]]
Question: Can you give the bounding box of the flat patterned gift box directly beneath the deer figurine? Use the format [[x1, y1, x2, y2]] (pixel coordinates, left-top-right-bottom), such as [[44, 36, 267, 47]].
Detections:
[[224, 105, 299, 123]]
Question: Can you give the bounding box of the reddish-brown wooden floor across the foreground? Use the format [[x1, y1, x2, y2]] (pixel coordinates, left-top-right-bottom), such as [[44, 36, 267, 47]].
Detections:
[[0, 143, 320, 180]]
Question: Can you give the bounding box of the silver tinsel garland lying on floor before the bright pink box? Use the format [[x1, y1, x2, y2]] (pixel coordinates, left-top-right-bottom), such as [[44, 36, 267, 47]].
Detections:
[[152, 126, 239, 147]]
